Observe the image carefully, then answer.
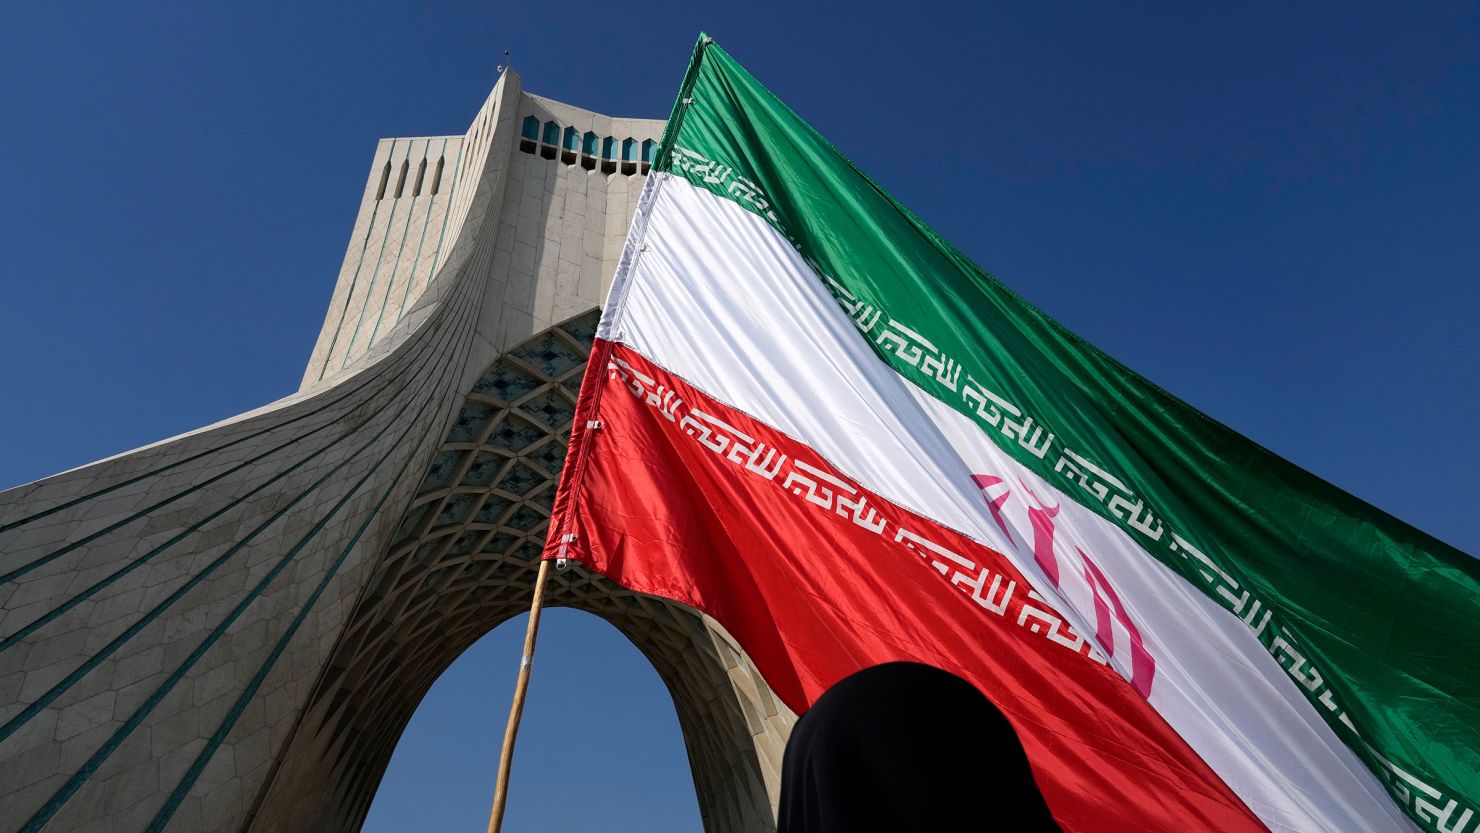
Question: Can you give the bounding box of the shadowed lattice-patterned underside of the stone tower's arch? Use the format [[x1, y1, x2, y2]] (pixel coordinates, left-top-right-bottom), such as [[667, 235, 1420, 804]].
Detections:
[[248, 309, 795, 832]]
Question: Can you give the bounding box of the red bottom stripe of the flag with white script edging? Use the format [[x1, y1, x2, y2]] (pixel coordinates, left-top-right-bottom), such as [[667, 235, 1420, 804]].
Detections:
[[546, 340, 1265, 833]]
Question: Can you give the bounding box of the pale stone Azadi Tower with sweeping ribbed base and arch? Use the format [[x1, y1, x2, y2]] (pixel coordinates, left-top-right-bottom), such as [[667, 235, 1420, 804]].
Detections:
[[0, 72, 795, 833]]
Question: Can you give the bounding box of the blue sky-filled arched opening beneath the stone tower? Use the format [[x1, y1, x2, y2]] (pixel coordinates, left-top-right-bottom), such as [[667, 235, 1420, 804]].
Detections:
[[363, 608, 702, 833]]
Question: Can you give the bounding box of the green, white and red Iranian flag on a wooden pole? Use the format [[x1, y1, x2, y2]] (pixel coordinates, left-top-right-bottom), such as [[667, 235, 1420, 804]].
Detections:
[[546, 38, 1480, 833]]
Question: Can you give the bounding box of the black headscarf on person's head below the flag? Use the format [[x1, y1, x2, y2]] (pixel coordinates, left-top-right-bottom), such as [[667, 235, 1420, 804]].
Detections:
[[777, 663, 1060, 833]]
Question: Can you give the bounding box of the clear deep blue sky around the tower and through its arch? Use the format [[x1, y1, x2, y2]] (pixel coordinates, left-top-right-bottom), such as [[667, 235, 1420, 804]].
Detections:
[[0, 0, 1480, 833]]
